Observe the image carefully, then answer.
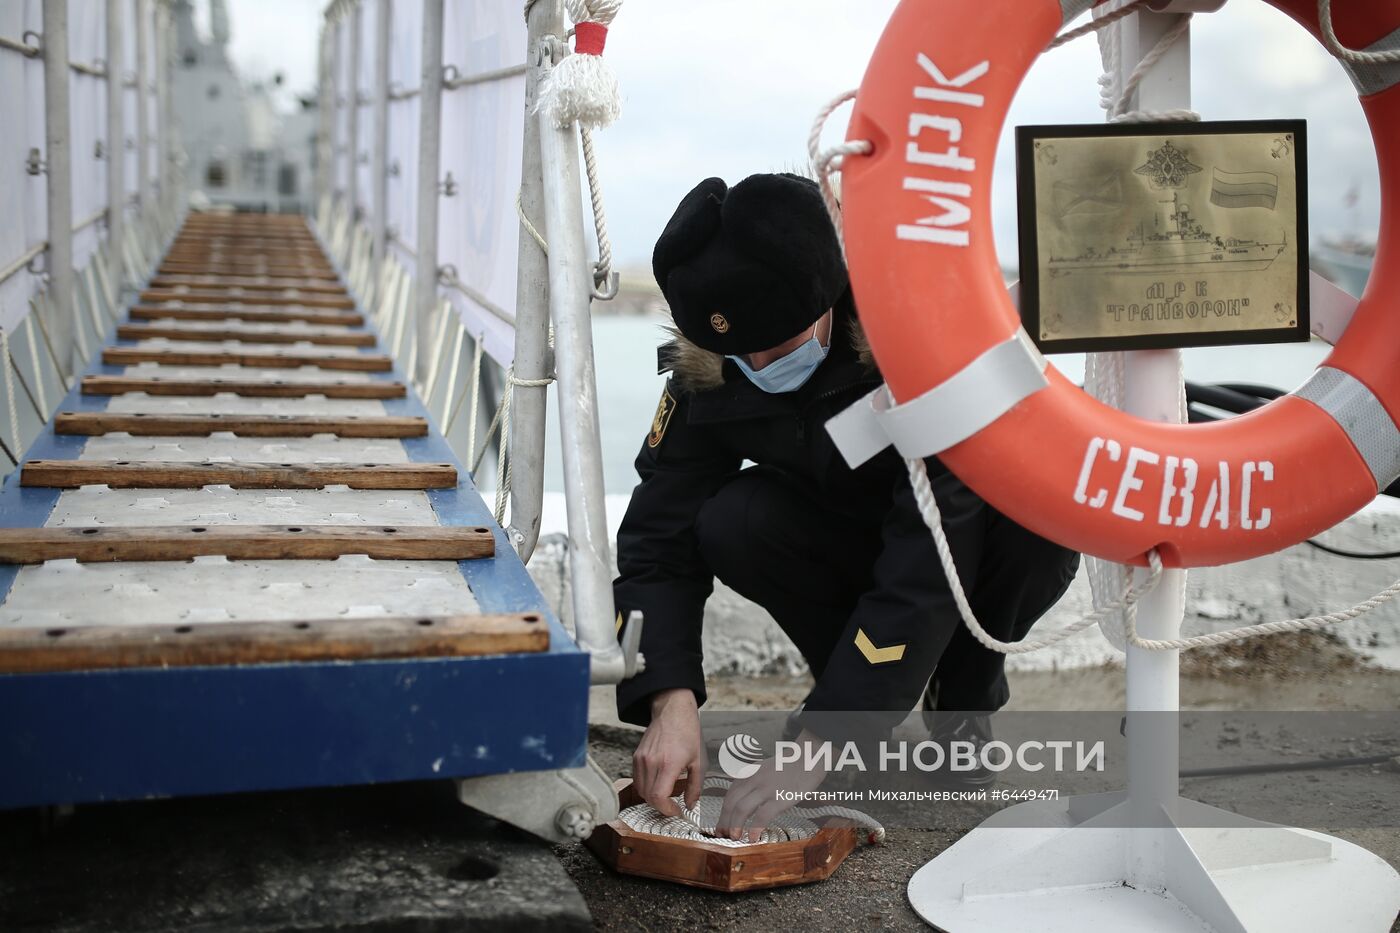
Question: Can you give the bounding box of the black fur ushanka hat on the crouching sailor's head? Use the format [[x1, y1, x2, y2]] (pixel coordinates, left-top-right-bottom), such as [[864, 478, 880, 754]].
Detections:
[[651, 174, 847, 354]]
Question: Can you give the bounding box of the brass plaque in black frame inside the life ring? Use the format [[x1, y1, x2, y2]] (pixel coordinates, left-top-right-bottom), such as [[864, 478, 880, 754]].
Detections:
[[1016, 120, 1309, 353]]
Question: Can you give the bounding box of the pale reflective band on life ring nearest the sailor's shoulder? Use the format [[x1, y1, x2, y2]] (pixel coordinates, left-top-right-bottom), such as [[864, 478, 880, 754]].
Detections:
[[826, 328, 1050, 469]]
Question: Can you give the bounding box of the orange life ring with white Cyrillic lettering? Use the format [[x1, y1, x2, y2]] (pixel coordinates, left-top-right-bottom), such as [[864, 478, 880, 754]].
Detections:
[[841, 0, 1400, 567]]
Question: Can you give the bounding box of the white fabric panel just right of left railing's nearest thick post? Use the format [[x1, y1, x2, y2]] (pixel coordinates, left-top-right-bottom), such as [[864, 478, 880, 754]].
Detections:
[[69, 0, 106, 269]]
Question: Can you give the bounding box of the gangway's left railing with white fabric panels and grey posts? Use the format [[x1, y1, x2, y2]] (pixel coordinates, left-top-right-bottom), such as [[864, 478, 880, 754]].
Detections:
[[0, 0, 183, 472]]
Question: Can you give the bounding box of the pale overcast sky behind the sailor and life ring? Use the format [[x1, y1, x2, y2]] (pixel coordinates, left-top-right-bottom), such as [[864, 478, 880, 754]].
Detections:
[[212, 0, 1379, 266]]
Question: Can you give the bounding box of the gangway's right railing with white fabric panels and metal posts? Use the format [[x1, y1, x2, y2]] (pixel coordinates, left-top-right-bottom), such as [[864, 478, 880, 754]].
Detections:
[[314, 0, 640, 684]]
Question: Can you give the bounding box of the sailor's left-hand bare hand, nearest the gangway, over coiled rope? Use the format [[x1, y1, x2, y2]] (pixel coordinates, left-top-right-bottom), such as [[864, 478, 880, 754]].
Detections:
[[631, 688, 710, 817]]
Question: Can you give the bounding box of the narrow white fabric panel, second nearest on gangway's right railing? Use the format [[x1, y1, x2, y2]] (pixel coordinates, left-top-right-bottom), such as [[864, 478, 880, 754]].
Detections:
[[388, 0, 423, 254]]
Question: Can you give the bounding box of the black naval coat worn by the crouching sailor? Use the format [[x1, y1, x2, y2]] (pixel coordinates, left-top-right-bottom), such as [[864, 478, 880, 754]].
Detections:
[[613, 291, 1078, 740]]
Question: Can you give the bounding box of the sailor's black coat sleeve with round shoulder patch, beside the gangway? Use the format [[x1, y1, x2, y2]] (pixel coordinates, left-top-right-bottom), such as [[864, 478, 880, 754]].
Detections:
[[613, 380, 742, 726]]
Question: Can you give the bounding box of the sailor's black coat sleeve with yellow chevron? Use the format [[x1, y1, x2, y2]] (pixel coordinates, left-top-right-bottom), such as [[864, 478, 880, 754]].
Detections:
[[802, 459, 990, 741]]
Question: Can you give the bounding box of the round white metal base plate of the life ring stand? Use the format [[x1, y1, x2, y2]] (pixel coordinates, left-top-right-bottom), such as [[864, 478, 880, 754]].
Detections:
[[909, 799, 1400, 933]]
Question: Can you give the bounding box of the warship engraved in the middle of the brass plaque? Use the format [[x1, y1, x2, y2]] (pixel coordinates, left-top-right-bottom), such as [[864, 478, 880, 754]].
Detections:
[[1047, 192, 1288, 277]]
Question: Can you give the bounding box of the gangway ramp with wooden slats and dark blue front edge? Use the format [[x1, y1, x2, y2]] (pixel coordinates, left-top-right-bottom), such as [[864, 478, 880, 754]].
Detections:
[[0, 214, 589, 807]]
